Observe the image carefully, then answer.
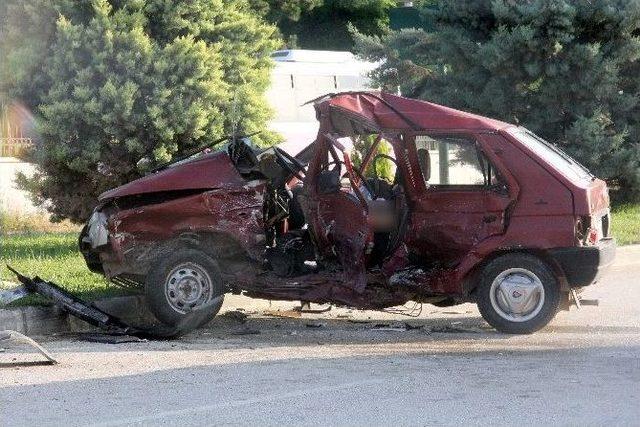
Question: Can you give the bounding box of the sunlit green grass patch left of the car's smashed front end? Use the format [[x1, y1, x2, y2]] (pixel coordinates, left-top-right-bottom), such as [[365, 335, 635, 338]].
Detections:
[[0, 233, 127, 305]]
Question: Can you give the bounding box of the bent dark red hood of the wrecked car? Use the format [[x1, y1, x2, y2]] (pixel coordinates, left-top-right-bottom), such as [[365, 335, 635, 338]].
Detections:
[[98, 152, 246, 201]]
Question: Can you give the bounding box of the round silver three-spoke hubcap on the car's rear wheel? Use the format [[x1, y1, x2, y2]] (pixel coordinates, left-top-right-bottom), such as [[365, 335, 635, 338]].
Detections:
[[490, 268, 544, 322]]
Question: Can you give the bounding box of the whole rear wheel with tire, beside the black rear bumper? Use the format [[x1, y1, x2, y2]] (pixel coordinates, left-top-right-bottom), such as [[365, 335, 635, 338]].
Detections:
[[476, 253, 561, 334]]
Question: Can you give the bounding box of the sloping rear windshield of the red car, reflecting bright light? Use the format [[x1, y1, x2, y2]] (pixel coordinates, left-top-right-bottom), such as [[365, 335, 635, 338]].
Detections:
[[509, 127, 594, 181]]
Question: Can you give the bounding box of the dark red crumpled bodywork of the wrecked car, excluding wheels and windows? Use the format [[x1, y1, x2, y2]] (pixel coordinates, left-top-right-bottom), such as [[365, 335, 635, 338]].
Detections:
[[81, 92, 610, 308]]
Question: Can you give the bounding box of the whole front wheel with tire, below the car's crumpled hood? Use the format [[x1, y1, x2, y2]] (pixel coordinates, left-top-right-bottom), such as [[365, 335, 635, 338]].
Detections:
[[145, 248, 224, 327]]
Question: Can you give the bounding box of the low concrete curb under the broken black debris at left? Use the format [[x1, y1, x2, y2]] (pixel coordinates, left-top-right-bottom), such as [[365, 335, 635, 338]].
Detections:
[[0, 296, 153, 335]]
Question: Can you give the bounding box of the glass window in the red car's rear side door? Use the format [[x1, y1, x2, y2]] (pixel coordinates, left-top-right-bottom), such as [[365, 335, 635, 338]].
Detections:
[[415, 135, 497, 187]]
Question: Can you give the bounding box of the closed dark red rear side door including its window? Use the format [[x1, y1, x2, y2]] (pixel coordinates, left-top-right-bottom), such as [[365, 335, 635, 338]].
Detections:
[[405, 133, 511, 265]]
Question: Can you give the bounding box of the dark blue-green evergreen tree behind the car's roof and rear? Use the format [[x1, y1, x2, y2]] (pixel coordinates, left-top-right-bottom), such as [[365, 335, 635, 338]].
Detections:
[[356, 0, 640, 198]]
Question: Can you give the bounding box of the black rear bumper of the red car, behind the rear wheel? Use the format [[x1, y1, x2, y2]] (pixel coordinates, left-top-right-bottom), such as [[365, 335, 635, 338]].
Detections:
[[549, 238, 616, 288]]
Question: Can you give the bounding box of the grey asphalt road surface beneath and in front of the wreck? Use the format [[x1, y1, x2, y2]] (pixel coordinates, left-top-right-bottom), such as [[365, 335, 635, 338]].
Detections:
[[0, 248, 640, 426]]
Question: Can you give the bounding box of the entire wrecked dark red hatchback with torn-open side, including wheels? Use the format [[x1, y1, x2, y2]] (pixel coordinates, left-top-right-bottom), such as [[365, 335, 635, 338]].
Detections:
[[80, 92, 615, 333]]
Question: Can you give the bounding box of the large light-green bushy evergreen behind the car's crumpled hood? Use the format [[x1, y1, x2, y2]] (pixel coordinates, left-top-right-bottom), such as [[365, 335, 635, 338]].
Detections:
[[0, 0, 277, 221]]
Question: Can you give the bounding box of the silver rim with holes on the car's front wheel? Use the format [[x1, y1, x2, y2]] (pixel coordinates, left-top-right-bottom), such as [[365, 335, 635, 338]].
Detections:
[[164, 262, 212, 314]]
